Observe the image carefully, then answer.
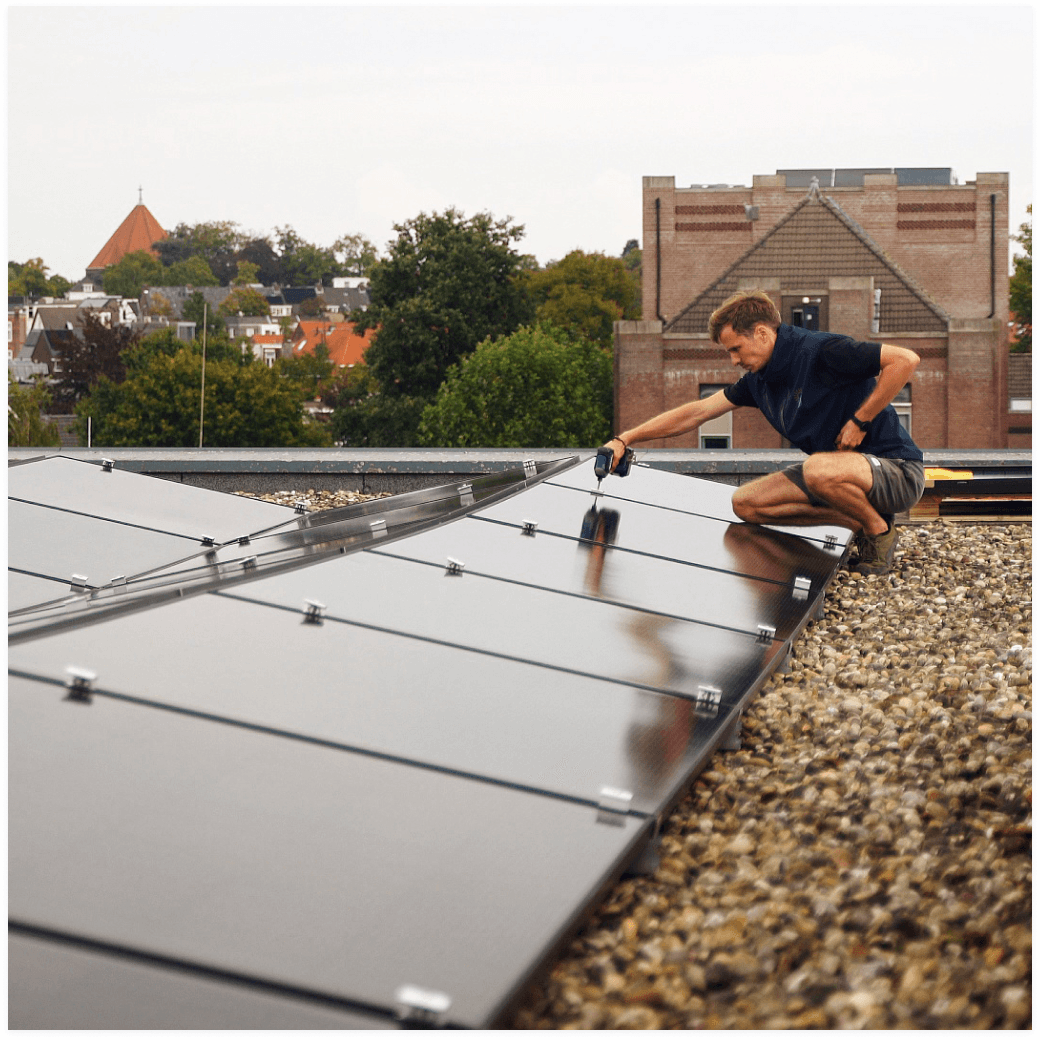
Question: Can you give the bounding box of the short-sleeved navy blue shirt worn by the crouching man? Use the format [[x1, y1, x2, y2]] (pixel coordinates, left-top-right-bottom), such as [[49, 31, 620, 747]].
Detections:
[[724, 324, 925, 461]]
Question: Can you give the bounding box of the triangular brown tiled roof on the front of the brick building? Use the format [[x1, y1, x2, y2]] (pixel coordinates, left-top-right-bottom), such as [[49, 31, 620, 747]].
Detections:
[[665, 188, 950, 333]]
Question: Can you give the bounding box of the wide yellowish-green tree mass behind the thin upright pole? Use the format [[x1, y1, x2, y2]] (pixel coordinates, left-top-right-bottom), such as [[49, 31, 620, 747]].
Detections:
[[76, 348, 329, 447]]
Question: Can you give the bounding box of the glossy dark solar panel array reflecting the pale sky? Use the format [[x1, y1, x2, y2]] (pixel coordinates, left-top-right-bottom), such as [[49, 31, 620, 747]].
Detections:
[[7, 458, 848, 1032]]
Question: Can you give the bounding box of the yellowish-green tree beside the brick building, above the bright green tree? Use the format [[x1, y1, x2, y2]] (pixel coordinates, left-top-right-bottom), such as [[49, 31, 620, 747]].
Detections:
[[527, 250, 641, 348]]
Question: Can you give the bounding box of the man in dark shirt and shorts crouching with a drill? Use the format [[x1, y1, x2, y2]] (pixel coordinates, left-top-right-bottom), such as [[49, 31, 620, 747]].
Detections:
[[607, 290, 925, 574]]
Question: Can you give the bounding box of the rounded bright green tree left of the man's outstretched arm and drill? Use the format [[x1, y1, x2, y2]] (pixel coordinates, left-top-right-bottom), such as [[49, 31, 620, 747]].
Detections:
[[419, 322, 613, 448]]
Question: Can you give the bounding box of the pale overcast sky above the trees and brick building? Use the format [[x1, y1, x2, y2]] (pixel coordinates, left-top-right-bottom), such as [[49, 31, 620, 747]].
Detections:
[[5, 5, 1034, 280]]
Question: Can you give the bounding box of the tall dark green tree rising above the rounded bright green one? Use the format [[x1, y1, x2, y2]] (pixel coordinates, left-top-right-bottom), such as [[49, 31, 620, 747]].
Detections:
[[357, 209, 534, 398]]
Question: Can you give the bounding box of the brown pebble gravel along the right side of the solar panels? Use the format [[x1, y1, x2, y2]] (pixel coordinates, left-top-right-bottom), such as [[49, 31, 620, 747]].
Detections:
[[510, 521, 1033, 1031]]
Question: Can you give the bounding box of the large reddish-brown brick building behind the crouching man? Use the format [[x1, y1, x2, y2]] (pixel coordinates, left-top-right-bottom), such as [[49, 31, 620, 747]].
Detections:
[[615, 168, 1009, 448]]
